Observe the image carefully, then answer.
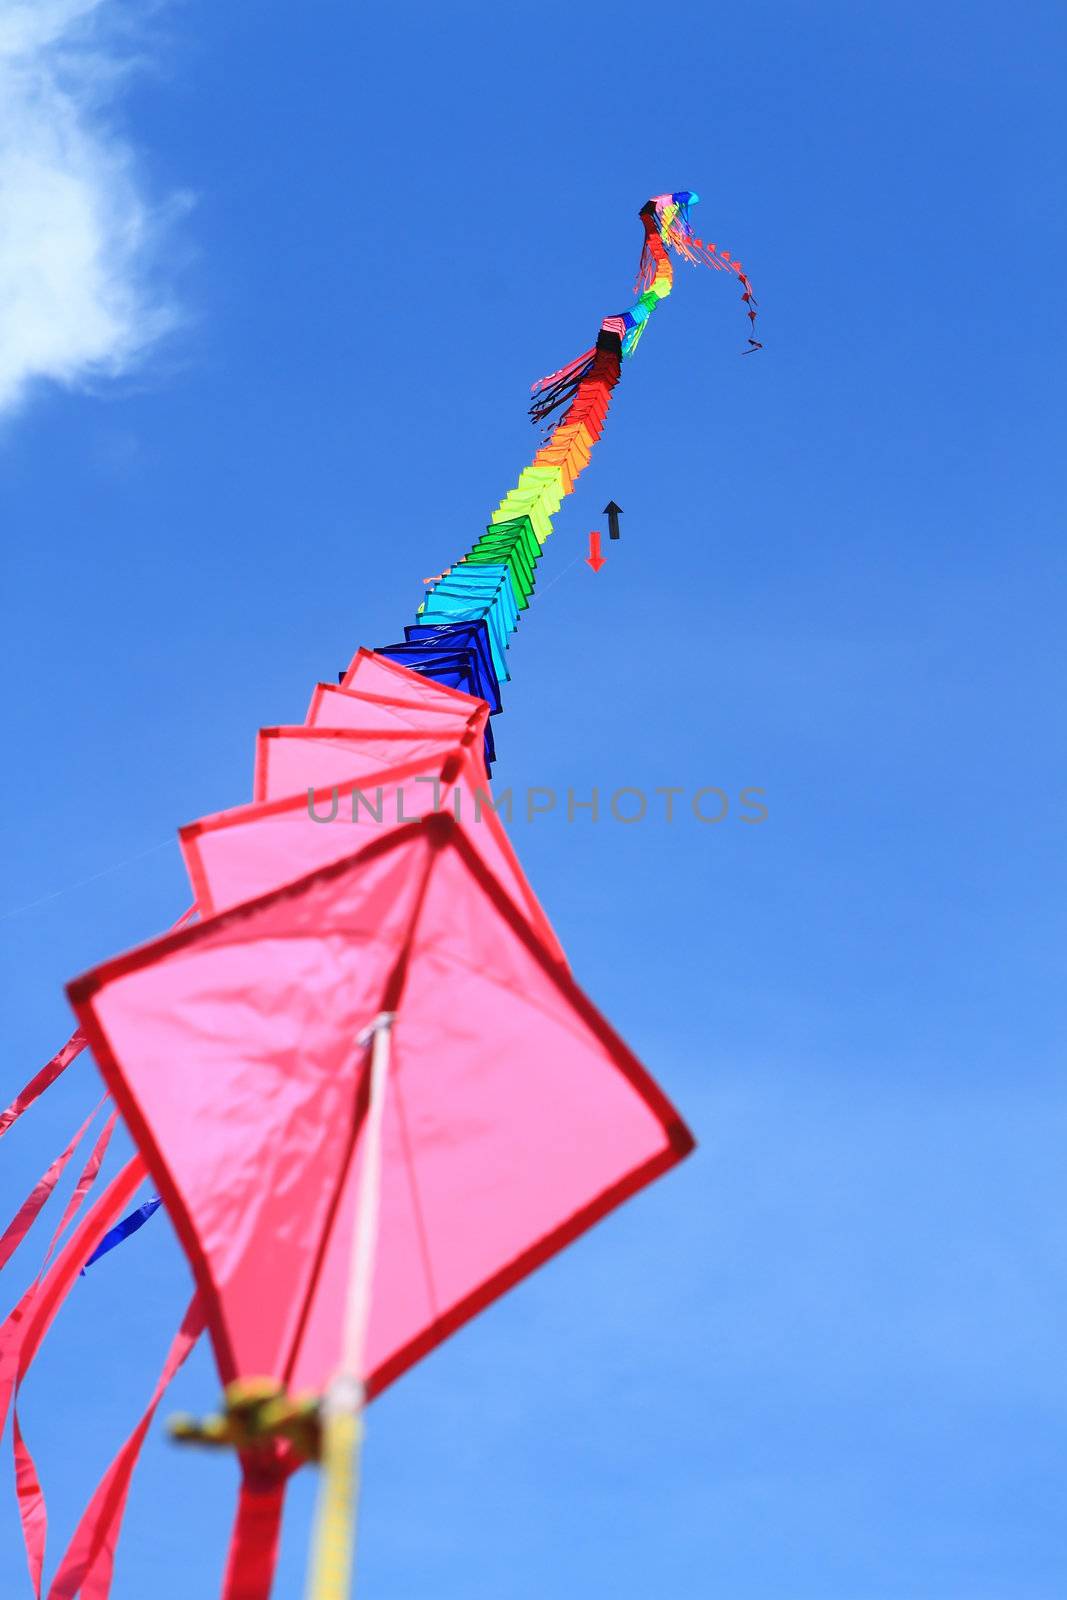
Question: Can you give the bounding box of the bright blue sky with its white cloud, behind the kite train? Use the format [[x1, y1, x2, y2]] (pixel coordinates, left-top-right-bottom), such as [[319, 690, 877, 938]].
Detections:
[[0, 0, 1067, 1600]]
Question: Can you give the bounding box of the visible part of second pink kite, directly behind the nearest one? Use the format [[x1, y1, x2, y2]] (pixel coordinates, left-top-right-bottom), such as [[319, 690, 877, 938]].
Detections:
[[179, 749, 565, 962]]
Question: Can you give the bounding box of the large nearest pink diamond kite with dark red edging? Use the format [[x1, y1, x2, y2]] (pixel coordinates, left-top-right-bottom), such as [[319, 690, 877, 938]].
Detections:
[[69, 813, 691, 1390]]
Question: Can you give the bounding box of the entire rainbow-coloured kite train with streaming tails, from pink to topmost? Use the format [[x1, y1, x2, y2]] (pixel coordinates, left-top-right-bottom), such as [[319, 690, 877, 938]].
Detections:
[[0, 194, 758, 1600]]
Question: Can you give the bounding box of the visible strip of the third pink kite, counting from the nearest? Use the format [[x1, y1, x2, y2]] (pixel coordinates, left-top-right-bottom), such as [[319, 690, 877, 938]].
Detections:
[[253, 726, 470, 802]]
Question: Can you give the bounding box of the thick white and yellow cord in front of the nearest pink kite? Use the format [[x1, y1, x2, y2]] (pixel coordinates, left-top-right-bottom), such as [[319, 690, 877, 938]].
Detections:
[[307, 1011, 395, 1600]]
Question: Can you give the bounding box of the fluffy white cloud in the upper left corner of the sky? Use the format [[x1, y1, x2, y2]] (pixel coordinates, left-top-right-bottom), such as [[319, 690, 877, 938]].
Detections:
[[0, 0, 184, 414]]
